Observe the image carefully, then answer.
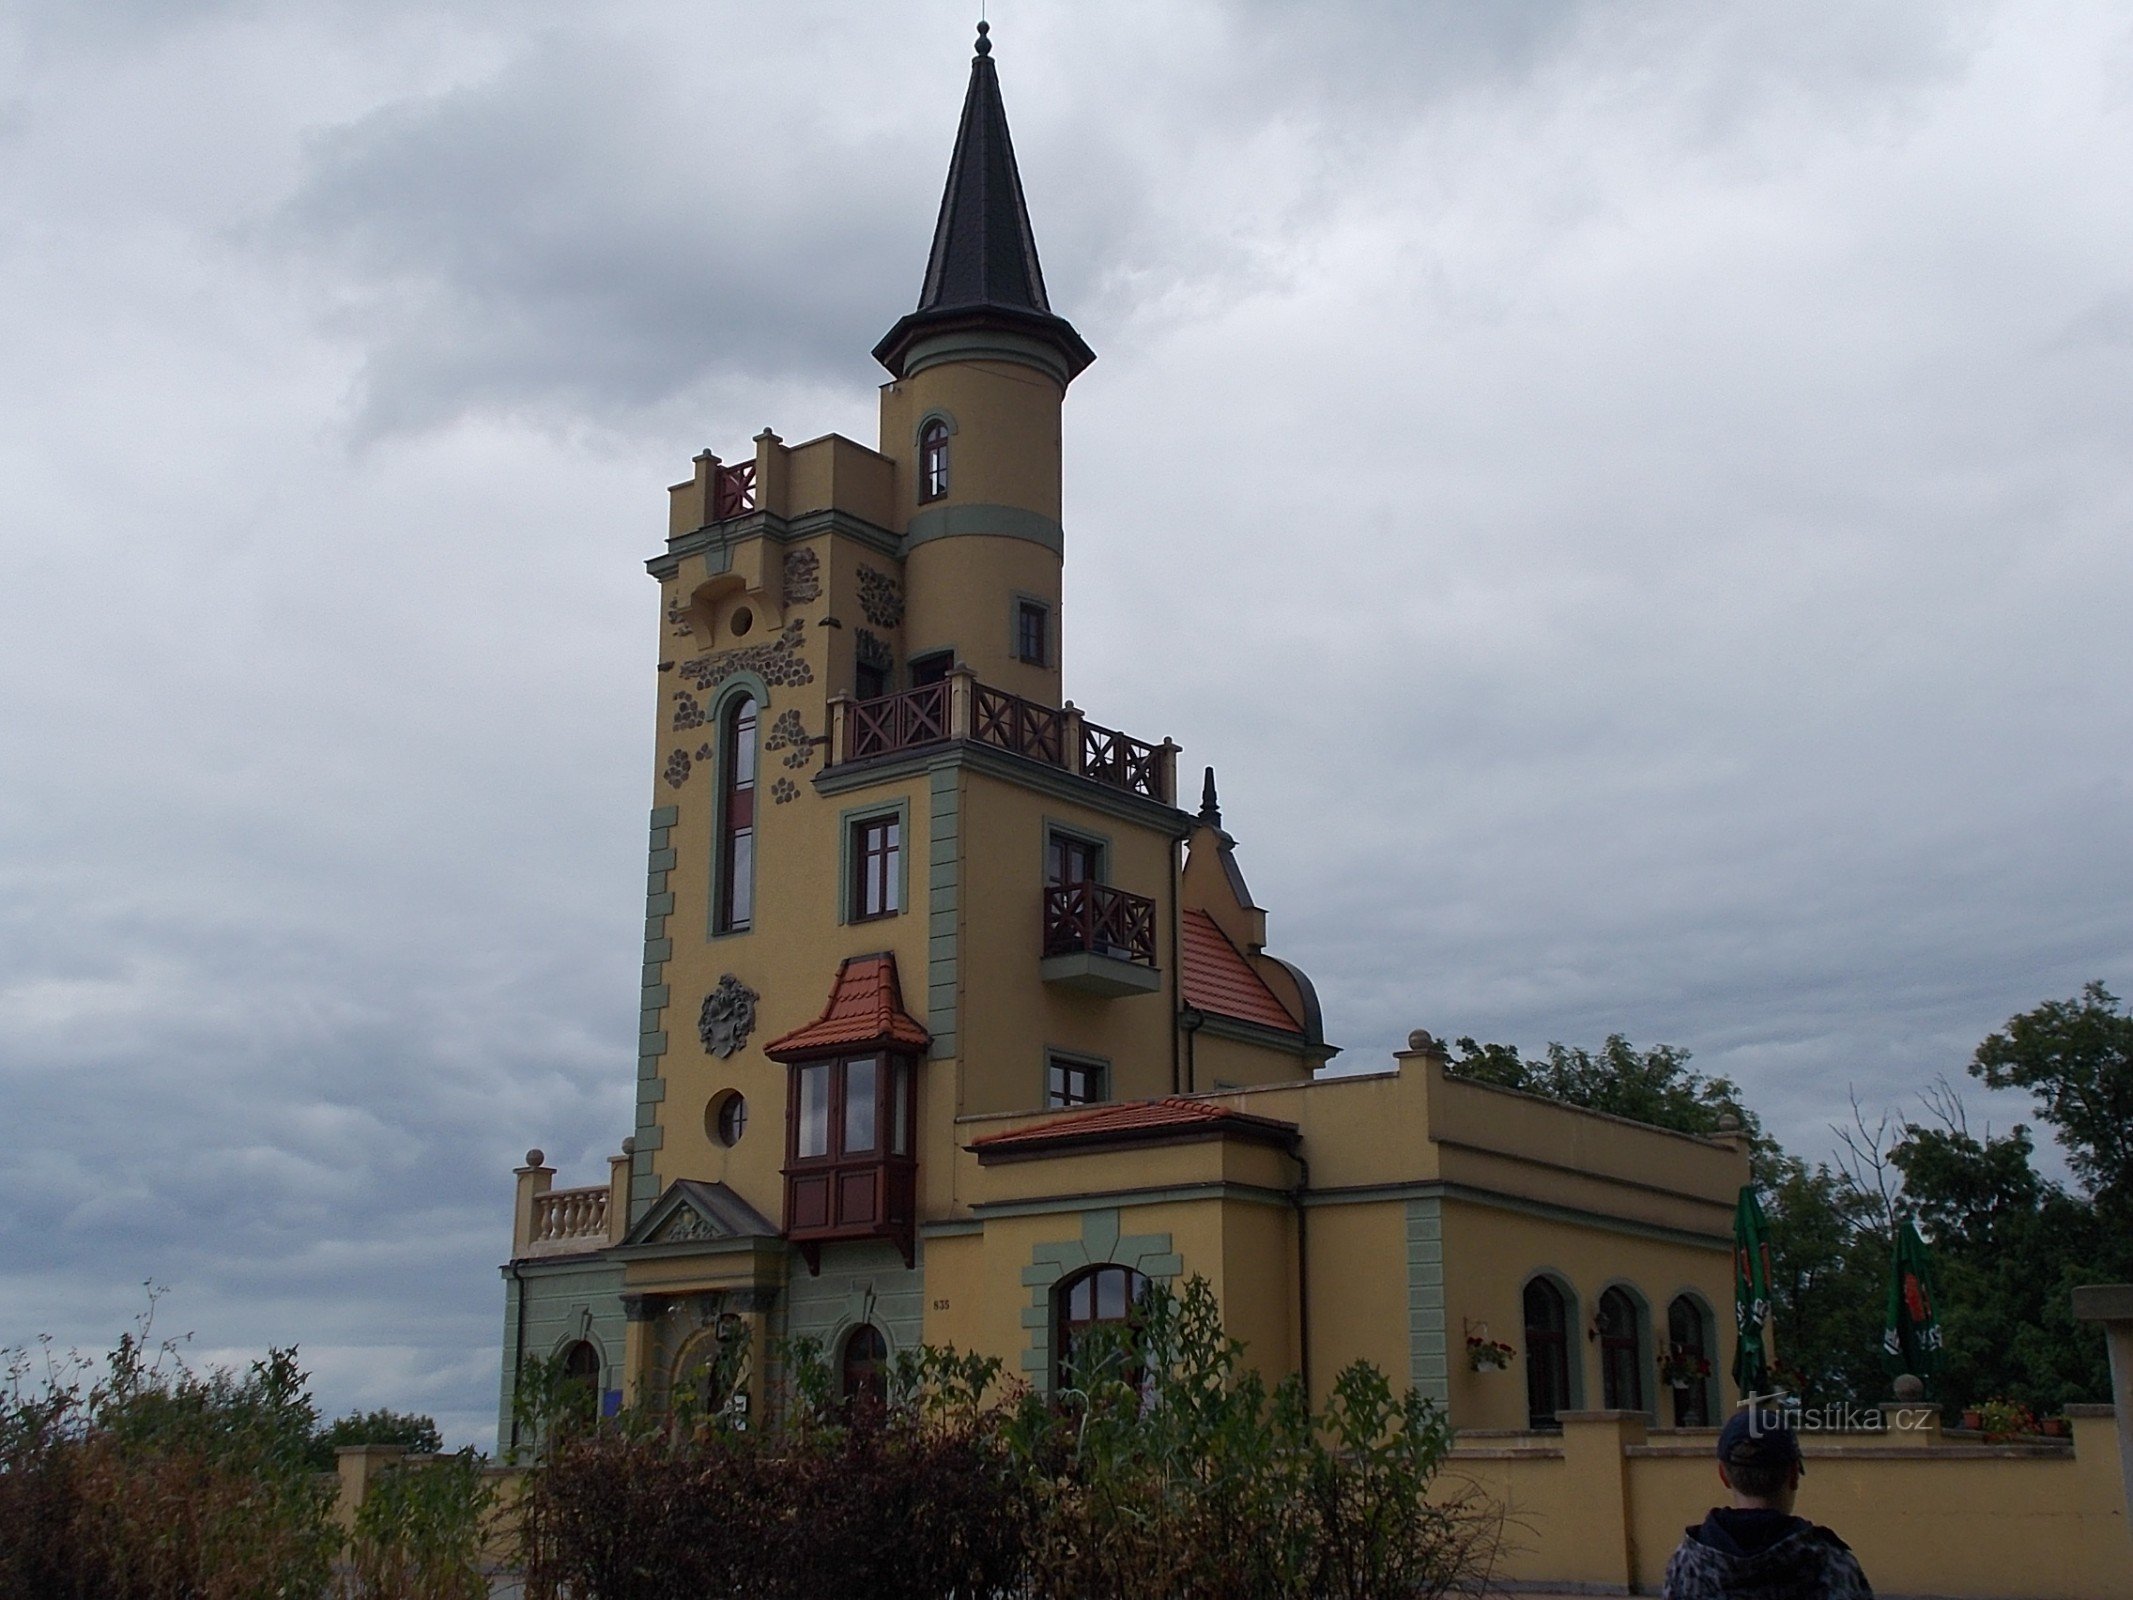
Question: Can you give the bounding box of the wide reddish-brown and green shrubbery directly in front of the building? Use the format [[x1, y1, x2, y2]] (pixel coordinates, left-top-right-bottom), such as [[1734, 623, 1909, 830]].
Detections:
[[525, 1280, 1499, 1600]]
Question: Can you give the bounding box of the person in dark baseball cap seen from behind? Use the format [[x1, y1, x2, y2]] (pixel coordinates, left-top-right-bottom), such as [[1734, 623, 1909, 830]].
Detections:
[[1664, 1406, 1873, 1600]]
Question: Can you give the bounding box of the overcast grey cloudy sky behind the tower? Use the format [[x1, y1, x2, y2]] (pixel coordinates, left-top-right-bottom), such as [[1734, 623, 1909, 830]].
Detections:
[[0, 0, 2133, 1442]]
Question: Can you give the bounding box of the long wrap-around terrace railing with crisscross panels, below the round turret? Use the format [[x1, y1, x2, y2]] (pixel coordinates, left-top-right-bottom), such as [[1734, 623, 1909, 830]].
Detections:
[[830, 668, 1177, 806]]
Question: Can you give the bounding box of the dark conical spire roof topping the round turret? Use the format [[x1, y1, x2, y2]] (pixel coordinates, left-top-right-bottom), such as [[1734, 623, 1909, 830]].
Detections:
[[875, 23, 1096, 378]]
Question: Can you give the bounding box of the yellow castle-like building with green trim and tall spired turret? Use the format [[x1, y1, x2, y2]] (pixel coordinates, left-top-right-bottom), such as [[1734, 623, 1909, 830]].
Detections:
[[501, 23, 1747, 1449]]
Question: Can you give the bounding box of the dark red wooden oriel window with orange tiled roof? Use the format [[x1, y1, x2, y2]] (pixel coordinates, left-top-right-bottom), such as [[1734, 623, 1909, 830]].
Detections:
[[764, 954, 930, 1271]]
